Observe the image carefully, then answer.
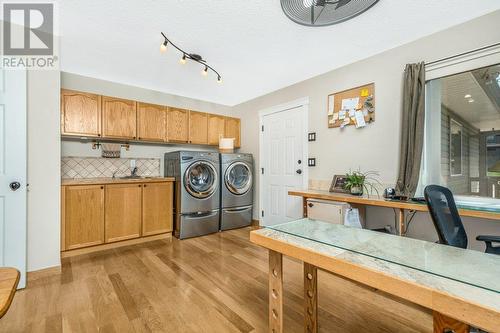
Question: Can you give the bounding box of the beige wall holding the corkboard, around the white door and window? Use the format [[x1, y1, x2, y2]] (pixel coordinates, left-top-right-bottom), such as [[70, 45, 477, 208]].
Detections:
[[234, 11, 500, 247]]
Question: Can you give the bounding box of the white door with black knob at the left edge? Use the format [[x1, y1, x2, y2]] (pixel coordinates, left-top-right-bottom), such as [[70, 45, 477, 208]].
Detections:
[[0, 69, 26, 288]]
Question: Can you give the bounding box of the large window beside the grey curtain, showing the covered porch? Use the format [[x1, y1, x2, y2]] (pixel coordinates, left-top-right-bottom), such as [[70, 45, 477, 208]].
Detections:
[[418, 64, 500, 199]]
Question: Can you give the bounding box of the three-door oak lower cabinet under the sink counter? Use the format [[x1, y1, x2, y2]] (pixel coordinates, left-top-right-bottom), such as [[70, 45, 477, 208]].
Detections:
[[61, 181, 174, 251]]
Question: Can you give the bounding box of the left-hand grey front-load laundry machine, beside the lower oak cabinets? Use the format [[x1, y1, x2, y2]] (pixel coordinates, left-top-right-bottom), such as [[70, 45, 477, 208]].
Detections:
[[164, 151, 220, 239]]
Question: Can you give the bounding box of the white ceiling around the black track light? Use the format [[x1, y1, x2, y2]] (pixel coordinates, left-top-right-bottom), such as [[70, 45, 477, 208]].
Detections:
[[59, 0, 500, 105]]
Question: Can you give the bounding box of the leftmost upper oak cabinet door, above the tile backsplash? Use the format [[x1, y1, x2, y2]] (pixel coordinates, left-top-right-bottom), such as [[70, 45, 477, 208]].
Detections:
[[61, 89, 101, 136]]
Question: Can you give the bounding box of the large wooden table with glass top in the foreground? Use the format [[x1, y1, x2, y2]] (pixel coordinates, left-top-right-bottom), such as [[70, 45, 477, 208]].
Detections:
[[250, 220, 500, 333]]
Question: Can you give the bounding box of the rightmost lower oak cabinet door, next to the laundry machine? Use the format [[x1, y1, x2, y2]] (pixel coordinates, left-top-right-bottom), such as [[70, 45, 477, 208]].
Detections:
[[142, 182, 173, 236]]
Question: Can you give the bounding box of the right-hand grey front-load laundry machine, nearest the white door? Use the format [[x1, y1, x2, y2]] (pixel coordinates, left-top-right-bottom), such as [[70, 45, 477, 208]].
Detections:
[[220, 154, 253, 230]]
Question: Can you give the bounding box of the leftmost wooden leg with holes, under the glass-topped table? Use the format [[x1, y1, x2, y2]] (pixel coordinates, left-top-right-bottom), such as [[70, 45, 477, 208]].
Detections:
[[269, 250, 283, 333]]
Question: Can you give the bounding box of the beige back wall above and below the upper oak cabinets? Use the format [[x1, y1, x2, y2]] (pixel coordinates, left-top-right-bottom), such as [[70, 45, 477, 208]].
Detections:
[[61, 72, 231, 174]]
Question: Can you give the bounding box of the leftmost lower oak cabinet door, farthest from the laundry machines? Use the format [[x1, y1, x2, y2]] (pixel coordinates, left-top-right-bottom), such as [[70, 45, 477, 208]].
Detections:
[[63, 185, 104, 250]]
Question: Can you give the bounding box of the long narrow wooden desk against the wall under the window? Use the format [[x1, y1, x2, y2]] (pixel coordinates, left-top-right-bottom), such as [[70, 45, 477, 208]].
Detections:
[[288, 190, 500, 235]]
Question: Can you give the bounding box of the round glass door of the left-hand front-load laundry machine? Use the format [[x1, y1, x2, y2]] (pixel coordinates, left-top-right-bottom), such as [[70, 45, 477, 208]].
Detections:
[[184, 161, 217, 199]]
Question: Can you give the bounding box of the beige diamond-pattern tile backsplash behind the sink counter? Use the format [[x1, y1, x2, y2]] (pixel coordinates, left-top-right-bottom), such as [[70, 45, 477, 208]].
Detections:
[[61, 157, 161, 178]]
